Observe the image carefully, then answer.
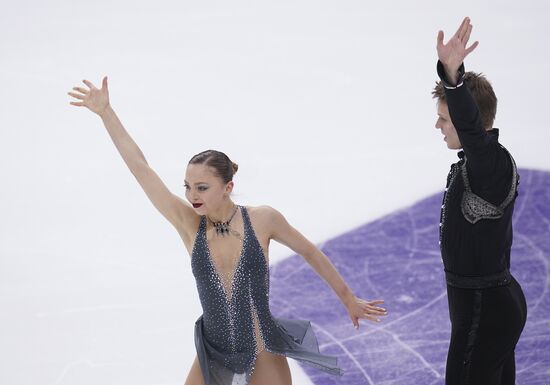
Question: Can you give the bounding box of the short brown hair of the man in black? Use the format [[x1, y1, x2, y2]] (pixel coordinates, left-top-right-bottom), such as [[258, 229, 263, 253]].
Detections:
[[432, 72, 497, 129]]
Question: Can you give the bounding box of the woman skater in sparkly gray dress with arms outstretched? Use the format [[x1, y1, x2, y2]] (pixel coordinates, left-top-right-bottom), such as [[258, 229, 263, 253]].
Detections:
[[69, 77, 386, 385]]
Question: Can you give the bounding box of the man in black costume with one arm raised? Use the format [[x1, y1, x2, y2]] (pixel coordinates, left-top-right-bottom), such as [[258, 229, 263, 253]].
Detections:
[[432, 18, 527, 385]]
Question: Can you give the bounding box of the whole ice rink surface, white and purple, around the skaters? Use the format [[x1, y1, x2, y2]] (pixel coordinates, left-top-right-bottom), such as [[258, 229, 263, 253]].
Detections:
[[0, 0, 550, 385]]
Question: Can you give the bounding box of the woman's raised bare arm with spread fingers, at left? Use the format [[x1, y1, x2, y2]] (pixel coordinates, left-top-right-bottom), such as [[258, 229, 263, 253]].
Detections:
[[69, 77, 199, 242]]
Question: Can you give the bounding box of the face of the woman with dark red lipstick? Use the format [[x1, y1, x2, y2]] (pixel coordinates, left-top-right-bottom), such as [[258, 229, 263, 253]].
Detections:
[[184, 164, 233, 215]]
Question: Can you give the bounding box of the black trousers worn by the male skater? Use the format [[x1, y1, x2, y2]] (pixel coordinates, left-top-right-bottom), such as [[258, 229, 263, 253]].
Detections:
[[445, 279, 527, 385]]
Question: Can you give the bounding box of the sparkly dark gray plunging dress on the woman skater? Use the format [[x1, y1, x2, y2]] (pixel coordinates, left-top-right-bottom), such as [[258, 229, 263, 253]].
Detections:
[[191, 206, 342, 385]]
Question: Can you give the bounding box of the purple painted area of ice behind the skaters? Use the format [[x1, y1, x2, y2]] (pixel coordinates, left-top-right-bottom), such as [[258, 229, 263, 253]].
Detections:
[[271, 170, 550, 385]]
